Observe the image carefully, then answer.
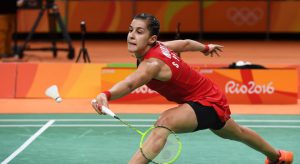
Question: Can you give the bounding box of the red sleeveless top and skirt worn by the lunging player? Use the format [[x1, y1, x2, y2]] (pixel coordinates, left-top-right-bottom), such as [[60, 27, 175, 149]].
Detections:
[[144, 42, 230, 121]]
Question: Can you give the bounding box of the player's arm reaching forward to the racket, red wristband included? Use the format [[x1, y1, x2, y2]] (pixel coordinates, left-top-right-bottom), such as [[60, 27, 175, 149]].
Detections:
[[92, 59, 162, 113]]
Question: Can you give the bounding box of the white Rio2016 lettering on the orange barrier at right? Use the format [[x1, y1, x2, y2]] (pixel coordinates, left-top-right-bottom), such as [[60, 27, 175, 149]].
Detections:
[[225, 81, 275, 94]]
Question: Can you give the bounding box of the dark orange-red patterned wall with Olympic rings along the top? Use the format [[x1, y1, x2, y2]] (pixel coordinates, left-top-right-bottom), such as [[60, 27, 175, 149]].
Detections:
[[17, 0, 300, 39]]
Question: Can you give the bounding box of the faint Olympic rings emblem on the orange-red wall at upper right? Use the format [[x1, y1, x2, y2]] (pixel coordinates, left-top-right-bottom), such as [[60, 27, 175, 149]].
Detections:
[[226, 7, 264, 26]]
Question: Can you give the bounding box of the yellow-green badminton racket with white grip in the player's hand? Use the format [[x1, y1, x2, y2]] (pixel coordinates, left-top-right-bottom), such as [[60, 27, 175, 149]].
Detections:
[[92, 100, 182, 164]]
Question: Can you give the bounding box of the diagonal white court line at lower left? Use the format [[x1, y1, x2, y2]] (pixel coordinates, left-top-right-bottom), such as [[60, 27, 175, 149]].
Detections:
[[1, 120, 55, 164]]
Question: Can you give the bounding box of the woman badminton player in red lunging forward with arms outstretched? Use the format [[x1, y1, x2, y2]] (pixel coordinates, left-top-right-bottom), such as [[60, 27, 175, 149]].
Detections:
[[92, 14, 293, 164]]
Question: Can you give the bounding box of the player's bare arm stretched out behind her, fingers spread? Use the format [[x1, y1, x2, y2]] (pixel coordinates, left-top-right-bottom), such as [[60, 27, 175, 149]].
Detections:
[[162, 39, 223, 56]]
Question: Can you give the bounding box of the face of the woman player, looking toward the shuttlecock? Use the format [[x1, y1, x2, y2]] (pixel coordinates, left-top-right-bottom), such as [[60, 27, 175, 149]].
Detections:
[[127, 19, 156, 57]]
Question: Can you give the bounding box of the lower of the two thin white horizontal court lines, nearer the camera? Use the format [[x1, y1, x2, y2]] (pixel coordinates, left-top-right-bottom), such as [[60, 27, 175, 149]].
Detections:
[[0, 124, 300, 129]]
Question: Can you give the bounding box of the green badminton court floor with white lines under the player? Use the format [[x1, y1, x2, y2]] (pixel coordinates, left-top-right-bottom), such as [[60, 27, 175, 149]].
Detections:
[[0, 114, 300, 164]]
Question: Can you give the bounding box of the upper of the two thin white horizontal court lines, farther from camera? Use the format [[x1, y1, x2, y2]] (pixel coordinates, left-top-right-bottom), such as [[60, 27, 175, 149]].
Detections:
[[0, 119, 300, 122]]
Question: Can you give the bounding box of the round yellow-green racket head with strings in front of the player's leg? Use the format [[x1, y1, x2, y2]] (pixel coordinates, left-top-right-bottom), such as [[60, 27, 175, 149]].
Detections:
[[140, 126, 182, 164]]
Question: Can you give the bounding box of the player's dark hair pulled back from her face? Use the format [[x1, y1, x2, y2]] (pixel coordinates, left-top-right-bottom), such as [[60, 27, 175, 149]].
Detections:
[[133, 13, 160, 36]]
